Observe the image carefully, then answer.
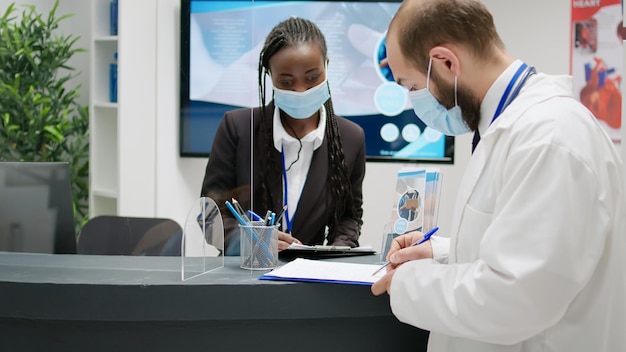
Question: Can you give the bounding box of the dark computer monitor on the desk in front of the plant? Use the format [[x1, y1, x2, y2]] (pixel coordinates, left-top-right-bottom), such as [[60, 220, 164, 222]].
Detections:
[[0, 161, 76, 254]]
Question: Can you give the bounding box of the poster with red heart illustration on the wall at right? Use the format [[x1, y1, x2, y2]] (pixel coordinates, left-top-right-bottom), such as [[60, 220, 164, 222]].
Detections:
[[571, 0, 626, 142]]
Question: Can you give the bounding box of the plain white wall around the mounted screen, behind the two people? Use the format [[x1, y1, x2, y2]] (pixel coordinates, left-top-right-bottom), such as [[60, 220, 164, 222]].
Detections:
[[150, 0, 570, 248]]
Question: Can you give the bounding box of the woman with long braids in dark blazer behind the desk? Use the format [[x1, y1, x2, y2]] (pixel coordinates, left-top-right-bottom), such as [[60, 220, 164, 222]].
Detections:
[[202, 17, 365, 255]]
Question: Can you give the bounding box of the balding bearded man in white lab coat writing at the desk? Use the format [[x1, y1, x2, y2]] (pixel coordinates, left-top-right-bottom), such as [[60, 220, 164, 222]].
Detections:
[[372, 0, 626, 352]]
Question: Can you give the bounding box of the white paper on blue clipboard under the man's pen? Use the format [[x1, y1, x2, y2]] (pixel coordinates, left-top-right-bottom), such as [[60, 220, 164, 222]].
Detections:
[[259, 258, 386, 286]]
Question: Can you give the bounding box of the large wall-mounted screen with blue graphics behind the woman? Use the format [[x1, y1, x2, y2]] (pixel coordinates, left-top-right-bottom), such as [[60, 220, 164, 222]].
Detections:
[[180, 0, 454, 163]]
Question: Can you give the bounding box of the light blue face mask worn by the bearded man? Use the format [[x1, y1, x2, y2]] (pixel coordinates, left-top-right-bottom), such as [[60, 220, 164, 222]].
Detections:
[[409, 59, 471, 136]]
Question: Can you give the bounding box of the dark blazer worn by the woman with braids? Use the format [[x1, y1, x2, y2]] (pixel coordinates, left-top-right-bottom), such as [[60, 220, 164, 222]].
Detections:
[[201, 103, 365, 247]]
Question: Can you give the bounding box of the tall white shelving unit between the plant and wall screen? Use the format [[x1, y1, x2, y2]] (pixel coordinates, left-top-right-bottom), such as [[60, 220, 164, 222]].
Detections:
[[89, 0, 157, 217]]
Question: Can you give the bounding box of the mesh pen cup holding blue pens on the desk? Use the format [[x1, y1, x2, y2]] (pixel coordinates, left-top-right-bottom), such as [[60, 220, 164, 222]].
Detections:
[[239, 221, 278, 270]]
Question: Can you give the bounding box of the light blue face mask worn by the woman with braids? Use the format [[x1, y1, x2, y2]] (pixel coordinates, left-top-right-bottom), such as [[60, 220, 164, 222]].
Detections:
[[274, 80, 330, 119]]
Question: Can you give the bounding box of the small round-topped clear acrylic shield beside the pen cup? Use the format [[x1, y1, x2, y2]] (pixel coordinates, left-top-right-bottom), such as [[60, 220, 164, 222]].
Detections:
[[181, 197, 224, 281]]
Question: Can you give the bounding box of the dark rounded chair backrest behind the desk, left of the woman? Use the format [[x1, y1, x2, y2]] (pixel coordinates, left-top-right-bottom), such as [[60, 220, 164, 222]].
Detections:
[[78, 215, 183, 256]]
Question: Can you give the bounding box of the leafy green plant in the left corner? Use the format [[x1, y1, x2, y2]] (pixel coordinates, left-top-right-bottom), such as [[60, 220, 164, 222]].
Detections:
[[0, 0, 89, 233]]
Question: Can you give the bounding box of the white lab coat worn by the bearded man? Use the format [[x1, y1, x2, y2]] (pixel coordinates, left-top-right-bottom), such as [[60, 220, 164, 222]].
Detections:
[[390, 74, 626, 352]]
